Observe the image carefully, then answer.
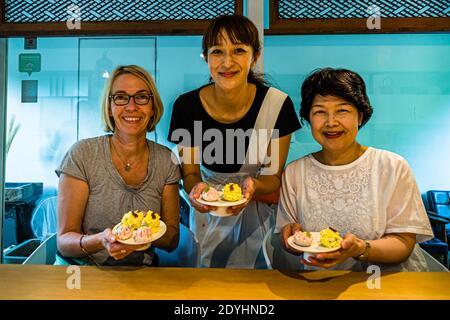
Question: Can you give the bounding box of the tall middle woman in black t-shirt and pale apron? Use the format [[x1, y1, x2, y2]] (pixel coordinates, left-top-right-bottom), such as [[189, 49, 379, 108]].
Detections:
[[169, 15, 300, 268]]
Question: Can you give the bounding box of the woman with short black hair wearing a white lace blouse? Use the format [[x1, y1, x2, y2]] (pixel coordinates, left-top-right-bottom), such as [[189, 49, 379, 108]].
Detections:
[[276, 68, 433, 271]]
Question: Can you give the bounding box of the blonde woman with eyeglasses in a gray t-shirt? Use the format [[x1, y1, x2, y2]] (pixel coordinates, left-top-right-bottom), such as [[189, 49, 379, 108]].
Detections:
[[56, 65, 181, 266]]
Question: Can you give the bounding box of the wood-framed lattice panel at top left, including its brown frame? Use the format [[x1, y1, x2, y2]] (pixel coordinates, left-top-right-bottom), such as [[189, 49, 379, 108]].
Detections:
[[0, 0, 243, 36]]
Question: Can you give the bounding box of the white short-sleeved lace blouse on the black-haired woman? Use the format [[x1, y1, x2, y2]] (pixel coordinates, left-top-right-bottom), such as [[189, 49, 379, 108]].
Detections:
[[275, 148, 433, 271]]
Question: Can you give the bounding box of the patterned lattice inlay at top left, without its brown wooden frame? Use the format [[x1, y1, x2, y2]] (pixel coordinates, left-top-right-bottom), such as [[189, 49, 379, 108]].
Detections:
[[5, 0, 234, 22]]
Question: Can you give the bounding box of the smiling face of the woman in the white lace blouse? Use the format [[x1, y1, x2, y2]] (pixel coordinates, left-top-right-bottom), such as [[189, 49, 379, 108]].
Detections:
[[309, 95, 362, 154]]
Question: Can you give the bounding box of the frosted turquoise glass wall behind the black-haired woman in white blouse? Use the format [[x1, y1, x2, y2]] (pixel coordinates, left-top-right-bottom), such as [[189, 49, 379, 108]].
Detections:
[[265, 34, 450, 192]]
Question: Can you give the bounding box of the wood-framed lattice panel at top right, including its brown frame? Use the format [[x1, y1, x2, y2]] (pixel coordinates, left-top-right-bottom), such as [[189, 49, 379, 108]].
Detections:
[[267, 0, 450, 34]]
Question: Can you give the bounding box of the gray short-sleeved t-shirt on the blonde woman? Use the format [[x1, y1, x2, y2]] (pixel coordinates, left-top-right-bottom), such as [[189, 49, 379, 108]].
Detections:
[[55, 135, 181, 265]]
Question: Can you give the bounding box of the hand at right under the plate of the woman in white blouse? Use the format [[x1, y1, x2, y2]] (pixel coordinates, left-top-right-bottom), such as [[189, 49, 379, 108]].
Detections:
[[302, 233, 366, 268]]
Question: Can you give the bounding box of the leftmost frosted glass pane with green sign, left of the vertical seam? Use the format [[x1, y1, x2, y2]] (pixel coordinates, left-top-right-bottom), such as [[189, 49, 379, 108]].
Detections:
[[6, 38, 78, 193]]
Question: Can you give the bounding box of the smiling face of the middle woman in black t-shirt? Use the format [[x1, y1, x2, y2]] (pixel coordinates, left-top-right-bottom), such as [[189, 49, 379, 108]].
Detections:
[[207, 31, 256, 90]]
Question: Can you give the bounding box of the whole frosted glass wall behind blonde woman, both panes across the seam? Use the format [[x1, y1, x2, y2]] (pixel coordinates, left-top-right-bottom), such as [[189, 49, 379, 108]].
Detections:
[[6, 37, 156, 195]]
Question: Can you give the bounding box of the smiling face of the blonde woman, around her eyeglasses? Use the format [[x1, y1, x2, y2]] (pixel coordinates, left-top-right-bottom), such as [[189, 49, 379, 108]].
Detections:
[[110, 74, 153, 136]]
